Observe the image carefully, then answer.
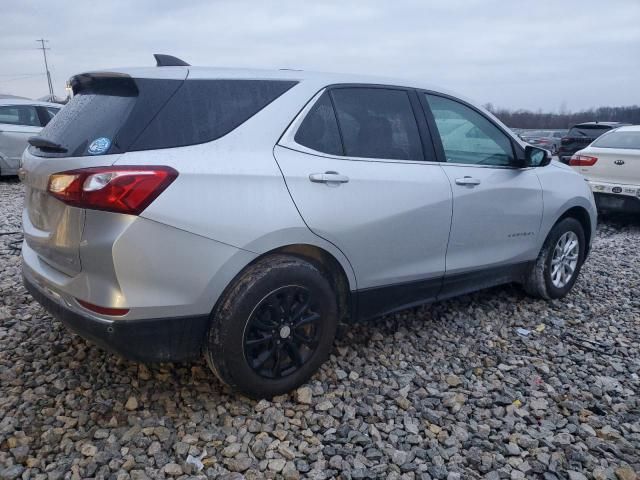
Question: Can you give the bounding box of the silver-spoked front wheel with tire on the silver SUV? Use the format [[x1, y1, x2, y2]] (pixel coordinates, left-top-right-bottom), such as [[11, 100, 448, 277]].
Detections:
[[524, 218, 586, 300]]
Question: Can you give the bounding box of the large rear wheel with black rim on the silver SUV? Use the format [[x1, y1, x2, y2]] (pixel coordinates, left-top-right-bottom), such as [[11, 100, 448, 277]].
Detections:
[[204, 254, 338, 398]]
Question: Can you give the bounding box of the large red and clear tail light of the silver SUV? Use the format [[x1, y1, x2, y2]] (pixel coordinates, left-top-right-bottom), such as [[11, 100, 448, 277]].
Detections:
[[48, 166, 178, 215]]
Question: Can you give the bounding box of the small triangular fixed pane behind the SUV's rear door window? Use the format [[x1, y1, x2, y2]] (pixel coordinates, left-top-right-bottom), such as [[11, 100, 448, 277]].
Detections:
[[294, 92, 342, 155]]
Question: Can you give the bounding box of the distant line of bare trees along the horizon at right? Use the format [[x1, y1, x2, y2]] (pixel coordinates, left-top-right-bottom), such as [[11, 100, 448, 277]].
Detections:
[[485, 104, 640, 129]]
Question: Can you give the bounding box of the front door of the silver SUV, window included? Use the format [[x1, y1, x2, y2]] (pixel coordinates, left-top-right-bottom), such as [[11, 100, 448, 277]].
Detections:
[[422, 93, 542, 296]]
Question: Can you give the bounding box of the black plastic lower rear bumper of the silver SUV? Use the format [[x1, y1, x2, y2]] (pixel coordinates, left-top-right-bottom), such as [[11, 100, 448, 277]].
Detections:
[[24, 272, 209, 363]]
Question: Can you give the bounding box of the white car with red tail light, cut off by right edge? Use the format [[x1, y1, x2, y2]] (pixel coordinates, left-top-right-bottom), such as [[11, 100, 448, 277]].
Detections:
[[569, 125, 640, 213]]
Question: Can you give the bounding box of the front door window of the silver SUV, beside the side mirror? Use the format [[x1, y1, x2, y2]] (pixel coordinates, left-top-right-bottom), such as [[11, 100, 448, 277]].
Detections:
[[426, 94, 515, 166]]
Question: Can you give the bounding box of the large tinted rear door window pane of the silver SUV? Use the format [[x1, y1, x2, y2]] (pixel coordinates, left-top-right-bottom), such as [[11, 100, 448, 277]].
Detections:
[[331, 87, 424, 160]]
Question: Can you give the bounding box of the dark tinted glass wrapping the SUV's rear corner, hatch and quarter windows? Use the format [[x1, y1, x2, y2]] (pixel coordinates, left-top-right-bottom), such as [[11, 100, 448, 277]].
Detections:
[[31, 75, 297, 157]]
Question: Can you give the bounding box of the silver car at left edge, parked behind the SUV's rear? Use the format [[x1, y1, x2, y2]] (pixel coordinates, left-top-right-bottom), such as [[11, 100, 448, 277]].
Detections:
[[0, 98, 61, 176]]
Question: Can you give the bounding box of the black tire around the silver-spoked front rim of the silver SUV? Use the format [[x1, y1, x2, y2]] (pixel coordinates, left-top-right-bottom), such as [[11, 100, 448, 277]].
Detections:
[[523, 217, 586, 300]]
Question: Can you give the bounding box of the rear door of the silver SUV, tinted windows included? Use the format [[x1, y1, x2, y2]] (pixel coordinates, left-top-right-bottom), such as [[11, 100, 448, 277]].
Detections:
[[275, 86, 451, 317]]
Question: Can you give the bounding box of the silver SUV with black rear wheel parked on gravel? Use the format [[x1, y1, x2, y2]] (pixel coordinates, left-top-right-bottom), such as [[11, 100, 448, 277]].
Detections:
[[21, 56, 596, 397]]
